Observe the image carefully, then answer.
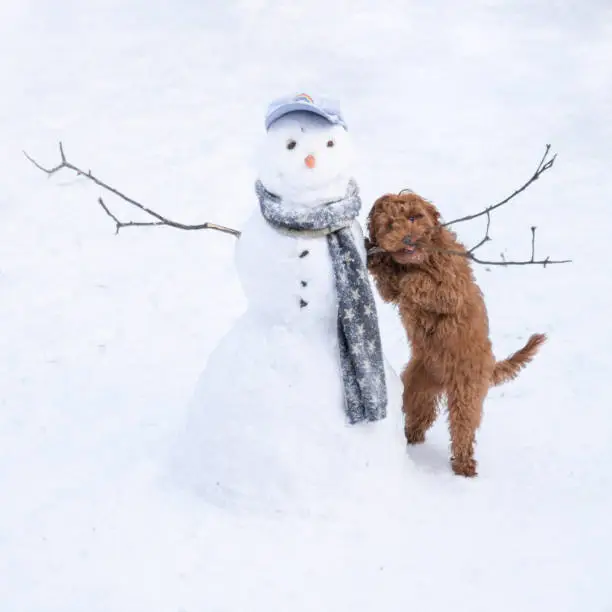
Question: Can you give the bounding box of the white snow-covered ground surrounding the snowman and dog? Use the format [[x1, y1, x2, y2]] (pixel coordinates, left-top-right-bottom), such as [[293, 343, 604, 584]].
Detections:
[[0, 0, 612, 612]]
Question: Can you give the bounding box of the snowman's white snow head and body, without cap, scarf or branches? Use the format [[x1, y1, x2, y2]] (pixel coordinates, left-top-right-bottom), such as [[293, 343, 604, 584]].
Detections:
[[172, 113, 403, 508]]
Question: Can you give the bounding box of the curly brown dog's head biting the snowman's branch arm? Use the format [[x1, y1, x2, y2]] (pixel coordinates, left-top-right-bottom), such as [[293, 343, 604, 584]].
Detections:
[[368, 192, 441, 264]]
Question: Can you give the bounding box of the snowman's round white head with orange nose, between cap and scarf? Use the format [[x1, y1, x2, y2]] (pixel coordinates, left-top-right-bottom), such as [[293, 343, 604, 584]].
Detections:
[[258, 110, 353, 205]]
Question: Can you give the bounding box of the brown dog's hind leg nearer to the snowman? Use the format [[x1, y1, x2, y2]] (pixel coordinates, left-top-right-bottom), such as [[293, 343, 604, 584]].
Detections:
[[402, 358, 442, 444]]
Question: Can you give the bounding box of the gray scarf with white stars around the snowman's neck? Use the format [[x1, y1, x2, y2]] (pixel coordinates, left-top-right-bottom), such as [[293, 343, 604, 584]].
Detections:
[[255, 180, 387, 424]]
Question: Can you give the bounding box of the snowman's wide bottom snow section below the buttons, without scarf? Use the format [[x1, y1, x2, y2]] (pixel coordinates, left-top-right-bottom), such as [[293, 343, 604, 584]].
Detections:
[[167, 313, 409, 511]]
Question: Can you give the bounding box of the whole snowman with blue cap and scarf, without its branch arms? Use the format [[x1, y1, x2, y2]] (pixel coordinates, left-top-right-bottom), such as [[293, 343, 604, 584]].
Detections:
[[171, 94, 405, 507]]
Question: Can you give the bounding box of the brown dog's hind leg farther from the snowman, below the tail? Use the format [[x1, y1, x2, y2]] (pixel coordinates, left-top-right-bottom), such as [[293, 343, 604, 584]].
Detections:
[[448, 381, 487, 477]]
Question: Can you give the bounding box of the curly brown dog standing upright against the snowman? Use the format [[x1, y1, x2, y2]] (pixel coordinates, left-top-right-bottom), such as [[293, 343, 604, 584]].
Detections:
[[366, 193, 546, 476]]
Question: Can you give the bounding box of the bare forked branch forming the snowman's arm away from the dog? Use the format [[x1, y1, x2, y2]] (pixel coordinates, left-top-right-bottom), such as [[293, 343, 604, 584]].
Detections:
[[23, 142, 240, 237]]
